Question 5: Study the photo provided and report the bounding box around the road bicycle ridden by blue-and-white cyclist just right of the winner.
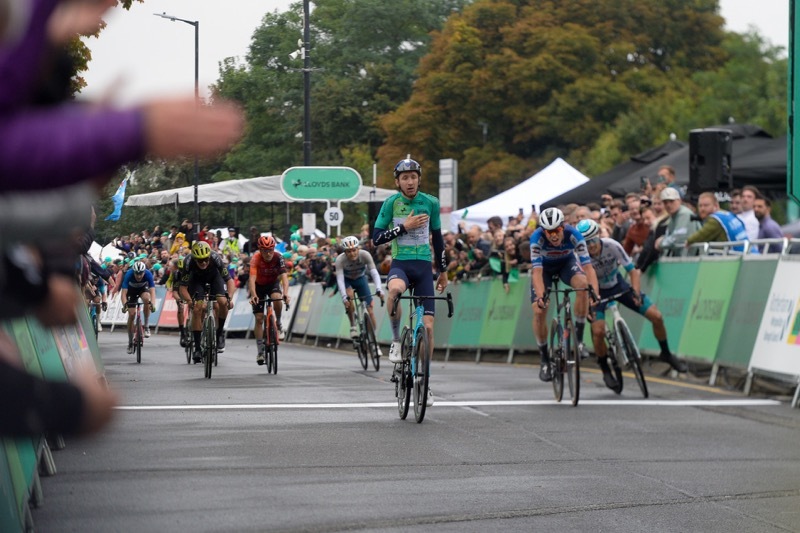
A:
[542,274,595,406]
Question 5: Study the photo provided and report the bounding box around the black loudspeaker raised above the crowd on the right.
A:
[689,129,733,193]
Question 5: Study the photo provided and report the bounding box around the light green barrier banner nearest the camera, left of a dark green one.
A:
[678,257,741,363]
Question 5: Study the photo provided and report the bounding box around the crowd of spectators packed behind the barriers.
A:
[103,166,783,294]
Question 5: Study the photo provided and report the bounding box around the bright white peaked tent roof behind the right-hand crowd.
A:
[450,157,589,231]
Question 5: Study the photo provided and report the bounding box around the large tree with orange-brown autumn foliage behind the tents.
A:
[378,0,725,205]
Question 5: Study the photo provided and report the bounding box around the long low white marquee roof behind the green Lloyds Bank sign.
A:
[125,176,395,207]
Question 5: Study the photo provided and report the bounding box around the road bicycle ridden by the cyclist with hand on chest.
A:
[391,286,453,424]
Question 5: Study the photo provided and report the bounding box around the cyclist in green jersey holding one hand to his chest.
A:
[372,157,447,405]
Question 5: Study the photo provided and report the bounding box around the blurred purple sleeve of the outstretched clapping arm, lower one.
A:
[0,105,144,192]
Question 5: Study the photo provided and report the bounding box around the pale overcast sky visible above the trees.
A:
[78,0,790,103]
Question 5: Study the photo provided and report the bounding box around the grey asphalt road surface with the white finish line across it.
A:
[33,332,800,533]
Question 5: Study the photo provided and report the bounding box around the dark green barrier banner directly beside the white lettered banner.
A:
[714,256,778,368]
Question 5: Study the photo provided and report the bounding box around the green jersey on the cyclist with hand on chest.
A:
[375,192,442,261]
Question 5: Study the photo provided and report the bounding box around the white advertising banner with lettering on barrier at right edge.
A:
[749,256,800,377]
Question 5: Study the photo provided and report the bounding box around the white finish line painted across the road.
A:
[116,399,781,411]
